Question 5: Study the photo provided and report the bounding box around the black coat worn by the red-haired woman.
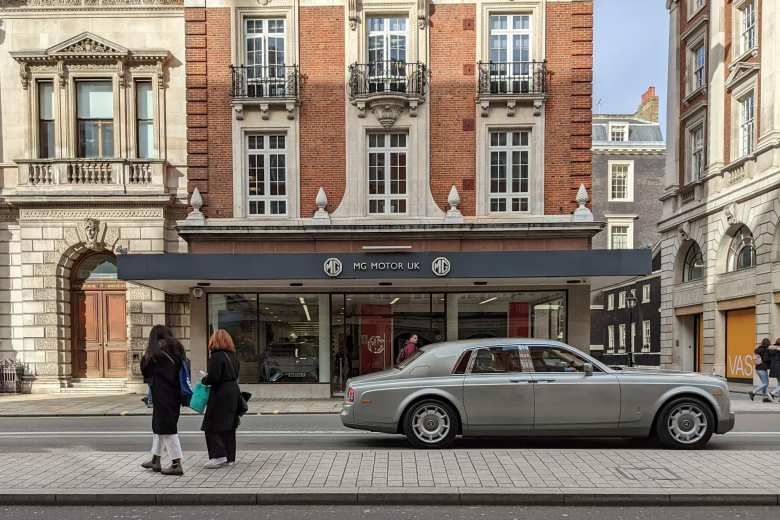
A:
[201,350,241,432]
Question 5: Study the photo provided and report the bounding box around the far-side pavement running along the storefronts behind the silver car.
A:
[0,392,780,417]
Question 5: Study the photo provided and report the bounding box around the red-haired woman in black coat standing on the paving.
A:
[201,329,242,469]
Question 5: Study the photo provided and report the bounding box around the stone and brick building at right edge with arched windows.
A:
[659,0,780,380]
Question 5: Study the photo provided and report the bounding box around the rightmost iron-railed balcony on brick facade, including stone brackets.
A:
[477,61,547,117]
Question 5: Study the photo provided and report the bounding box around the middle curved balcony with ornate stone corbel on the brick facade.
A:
[348,61,428,128]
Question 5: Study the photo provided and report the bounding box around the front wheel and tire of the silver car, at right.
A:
[655,397,715,450]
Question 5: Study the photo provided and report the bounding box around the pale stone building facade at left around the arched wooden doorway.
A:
[0,1,189,392]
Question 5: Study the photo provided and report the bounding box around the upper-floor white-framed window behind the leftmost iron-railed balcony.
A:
[244,18,286,97]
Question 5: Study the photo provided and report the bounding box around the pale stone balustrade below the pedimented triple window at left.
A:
[16,159,166,195]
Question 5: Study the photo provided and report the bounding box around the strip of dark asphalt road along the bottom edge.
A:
[0,506,778,520]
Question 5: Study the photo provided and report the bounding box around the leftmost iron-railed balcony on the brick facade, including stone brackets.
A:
[230,65,301,119]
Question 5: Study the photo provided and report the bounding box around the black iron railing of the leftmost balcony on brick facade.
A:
[230,65,300,98]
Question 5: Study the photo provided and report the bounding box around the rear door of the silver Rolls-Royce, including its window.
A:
[463,345,534,435]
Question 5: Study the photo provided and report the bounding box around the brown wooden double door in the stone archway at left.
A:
[71,286,127,378]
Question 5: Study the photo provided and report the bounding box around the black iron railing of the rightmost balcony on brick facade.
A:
[478,61,547,95]
